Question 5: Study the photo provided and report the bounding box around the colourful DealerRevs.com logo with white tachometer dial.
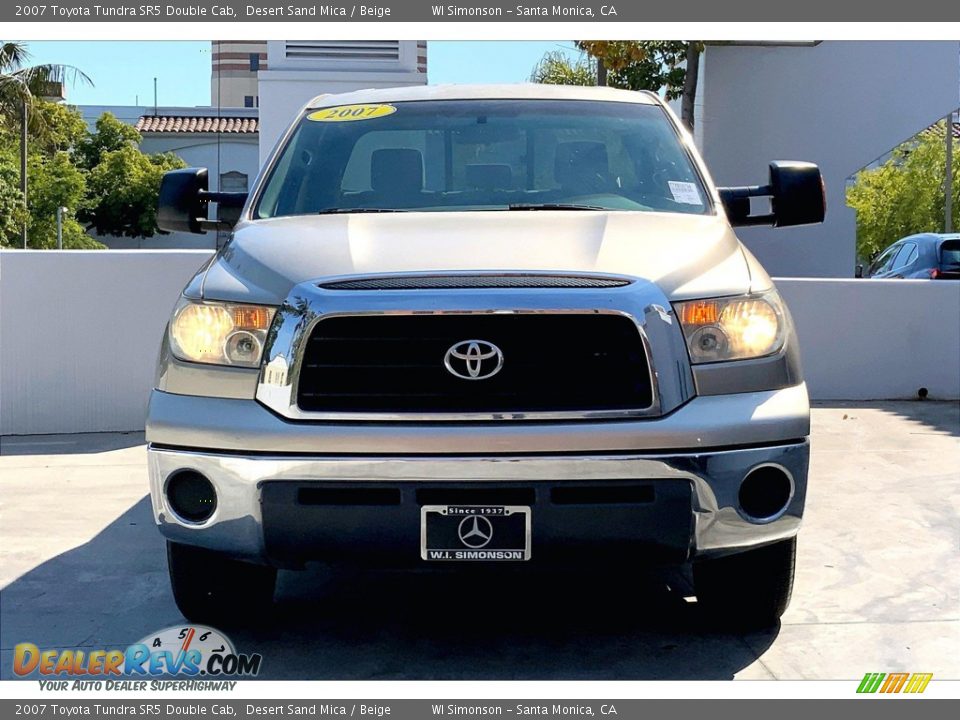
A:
[13,625,263,681]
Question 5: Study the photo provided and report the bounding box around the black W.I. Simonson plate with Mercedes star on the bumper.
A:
[420,505,530,562]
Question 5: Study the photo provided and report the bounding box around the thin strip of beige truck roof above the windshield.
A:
[307,83,660,108]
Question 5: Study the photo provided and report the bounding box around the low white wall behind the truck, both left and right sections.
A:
[0,250,960,434]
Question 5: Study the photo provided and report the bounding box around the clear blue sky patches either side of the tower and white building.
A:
[20,40,576,105]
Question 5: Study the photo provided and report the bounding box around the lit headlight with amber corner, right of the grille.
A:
[674,290,784,364]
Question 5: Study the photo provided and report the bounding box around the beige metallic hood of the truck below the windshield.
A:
[199,211,769,304]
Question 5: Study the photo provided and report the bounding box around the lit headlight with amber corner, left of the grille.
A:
[170,298,276,367]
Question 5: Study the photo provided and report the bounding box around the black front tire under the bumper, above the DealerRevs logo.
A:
[167,541,277,625]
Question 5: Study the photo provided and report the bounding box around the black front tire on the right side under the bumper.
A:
[693,537,797,629]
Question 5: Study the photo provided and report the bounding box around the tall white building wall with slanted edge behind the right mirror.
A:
[700,41,960,277]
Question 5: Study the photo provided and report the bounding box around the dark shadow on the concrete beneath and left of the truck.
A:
[0,497,779,680]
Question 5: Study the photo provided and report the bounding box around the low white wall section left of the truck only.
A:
[0,250,210,435]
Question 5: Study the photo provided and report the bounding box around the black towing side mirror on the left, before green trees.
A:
[157,168,247,233]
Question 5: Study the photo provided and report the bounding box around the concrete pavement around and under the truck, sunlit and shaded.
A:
[0,402,960,681]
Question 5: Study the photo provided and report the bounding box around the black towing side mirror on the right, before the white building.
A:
[719,160,827,227]
